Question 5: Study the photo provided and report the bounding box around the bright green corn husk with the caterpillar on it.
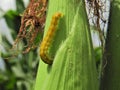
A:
[35,0,98,90]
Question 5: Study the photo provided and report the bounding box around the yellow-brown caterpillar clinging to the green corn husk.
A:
[40,12,63,65]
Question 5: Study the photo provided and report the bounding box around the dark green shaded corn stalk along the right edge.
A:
[101,0,120,90]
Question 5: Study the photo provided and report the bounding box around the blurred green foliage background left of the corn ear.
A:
[0,0,39,90]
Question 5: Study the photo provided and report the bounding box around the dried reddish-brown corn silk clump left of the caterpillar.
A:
[13,0,47,53]
